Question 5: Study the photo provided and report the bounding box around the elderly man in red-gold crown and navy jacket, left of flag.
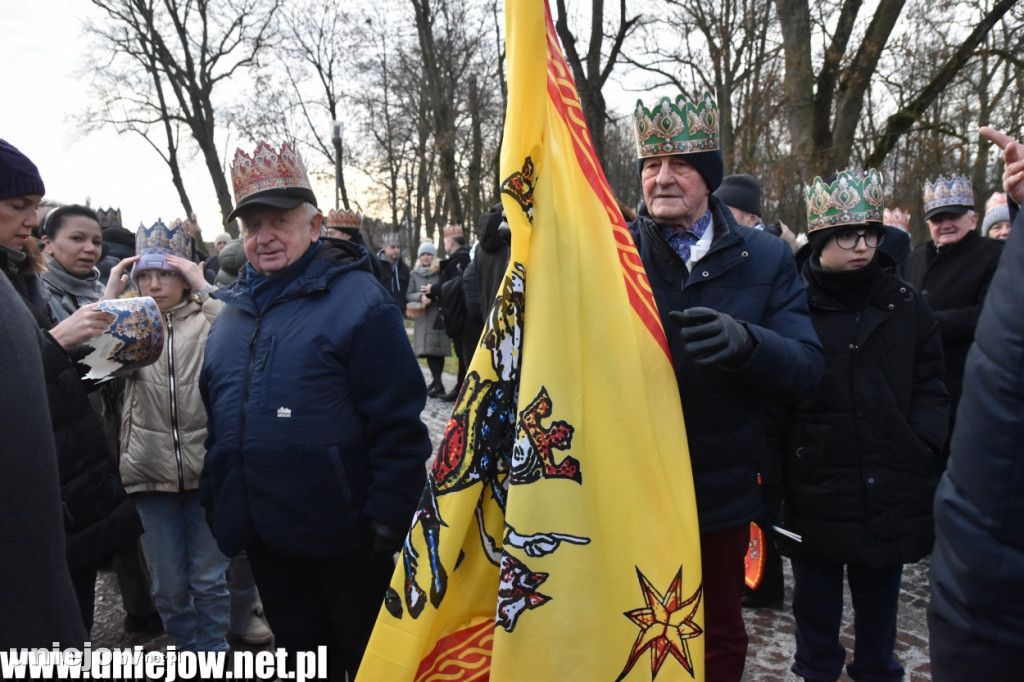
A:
[200,142,431,680]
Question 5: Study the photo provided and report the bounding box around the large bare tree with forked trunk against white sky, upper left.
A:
[85,0,281,231]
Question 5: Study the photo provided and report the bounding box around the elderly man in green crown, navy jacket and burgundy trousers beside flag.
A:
[631,93,824,682]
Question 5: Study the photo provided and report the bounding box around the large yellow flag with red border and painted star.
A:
[358,0,703,682]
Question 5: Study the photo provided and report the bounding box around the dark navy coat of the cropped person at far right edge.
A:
[928,205,1024,643]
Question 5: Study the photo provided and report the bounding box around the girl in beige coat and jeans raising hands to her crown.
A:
[108,223,230,651]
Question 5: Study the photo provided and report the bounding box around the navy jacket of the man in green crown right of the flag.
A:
[630,197,824,532]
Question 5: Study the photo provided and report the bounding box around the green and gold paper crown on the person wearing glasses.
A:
[807,168,885,232]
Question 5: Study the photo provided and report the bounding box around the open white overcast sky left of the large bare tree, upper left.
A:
[0,0,221,241]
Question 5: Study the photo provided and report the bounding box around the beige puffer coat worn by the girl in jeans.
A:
[121,293,224,493]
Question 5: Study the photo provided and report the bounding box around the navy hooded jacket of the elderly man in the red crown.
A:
[200,241,431,557]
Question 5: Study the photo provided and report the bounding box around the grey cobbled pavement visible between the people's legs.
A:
[92,370,932,682]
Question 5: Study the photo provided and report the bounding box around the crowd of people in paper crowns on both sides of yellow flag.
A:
[0,86,1024,682]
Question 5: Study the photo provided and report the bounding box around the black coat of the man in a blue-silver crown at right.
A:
[903,231,1002,411]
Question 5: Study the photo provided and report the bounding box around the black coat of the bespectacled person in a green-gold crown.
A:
[782,248,948,567]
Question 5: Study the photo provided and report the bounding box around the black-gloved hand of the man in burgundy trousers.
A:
[669,307,754,370]
